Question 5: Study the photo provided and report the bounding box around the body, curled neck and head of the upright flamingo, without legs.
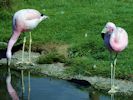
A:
[102,22,128,53]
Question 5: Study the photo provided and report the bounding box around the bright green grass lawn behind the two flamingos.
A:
[0,0,133,78]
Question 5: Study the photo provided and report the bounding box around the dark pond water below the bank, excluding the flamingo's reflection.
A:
[0,68,132,100]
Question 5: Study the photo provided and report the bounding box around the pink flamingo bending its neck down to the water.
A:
[6,9,48,65]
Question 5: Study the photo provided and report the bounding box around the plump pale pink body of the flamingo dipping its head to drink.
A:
[13,9,45,32]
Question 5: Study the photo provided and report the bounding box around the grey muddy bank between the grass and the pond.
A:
[0,51,133,95]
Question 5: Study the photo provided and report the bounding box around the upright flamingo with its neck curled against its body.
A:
[101,22,128,94]
